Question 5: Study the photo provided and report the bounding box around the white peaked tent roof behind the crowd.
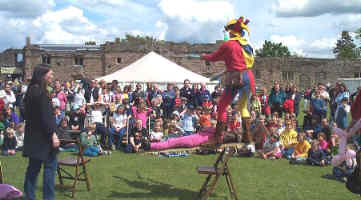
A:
[97,51,209,83]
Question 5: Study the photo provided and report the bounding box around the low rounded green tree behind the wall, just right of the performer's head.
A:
[256,40,291,57]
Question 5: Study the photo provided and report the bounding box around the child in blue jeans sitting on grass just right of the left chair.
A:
[80,123,109,157]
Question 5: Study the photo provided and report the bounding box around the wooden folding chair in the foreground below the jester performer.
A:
[197,148,238,200]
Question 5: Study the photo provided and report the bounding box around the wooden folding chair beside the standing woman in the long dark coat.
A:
[57,131,90,198]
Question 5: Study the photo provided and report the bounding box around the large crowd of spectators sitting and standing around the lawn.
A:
[0,79,361,180]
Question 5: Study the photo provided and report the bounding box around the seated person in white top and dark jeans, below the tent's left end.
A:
[108,105,130,150]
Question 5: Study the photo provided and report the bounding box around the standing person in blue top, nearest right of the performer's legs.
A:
[268,83,286,116]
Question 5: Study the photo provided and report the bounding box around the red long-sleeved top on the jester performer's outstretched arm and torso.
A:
[203,40,247,71]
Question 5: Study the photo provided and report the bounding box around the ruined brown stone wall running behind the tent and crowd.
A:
[0,40,361,88]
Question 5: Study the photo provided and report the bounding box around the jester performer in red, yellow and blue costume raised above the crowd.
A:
[202,17,256,144]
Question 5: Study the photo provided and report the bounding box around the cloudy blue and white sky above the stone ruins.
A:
[0,0,361,58]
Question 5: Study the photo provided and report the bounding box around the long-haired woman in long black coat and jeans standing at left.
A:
[23,65,60,200]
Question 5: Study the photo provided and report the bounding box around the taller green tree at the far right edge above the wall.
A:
[333,31,360,59]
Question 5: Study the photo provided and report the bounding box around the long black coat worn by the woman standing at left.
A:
[23,85,57,161]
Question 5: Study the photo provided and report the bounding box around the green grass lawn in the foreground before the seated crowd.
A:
[1,152,360,200]
